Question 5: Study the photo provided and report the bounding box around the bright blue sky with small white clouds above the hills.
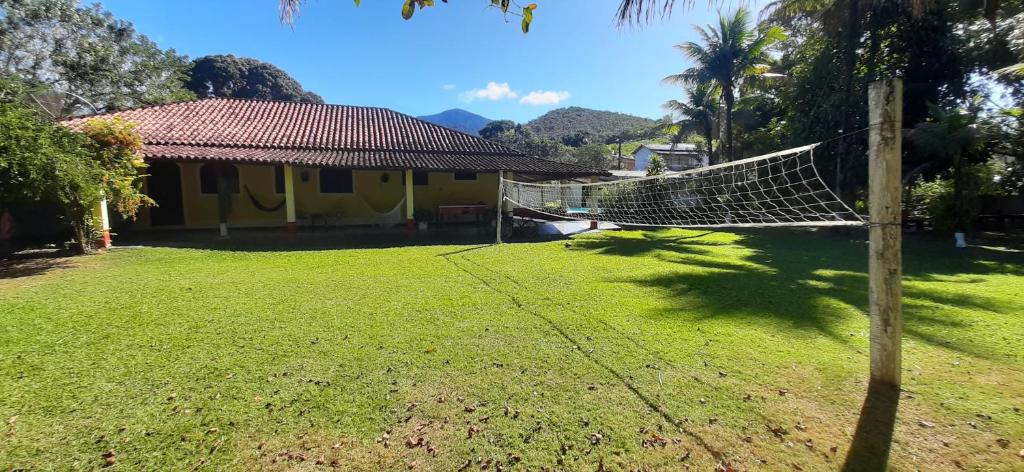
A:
[102,0,761,122]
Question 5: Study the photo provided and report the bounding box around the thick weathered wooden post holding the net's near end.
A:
[867,79,903,387]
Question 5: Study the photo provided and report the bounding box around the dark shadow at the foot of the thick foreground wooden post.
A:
[842,381,899,472]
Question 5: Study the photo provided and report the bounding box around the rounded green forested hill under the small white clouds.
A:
[526,106,657,141]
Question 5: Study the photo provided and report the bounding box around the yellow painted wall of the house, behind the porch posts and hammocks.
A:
[135,163,498,228]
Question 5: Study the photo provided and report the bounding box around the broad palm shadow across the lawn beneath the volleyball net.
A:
[572,229,1024,357]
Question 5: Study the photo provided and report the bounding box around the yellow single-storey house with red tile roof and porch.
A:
[63,98,604,237]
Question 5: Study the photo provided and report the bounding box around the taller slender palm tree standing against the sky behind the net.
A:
[665,8,785,161]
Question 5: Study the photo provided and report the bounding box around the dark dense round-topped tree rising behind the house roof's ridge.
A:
[185,54,324,103]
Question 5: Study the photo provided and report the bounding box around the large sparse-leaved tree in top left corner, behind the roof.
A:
[0,0,194,117]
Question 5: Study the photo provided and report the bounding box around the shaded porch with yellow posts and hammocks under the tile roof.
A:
[132,161,511,232]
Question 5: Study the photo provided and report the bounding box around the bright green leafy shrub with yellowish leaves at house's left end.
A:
[0,80,154,252]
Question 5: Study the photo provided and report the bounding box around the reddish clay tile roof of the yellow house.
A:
[63,98,604,176]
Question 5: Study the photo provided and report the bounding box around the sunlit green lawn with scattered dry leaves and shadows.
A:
[0,230,1024,470]
